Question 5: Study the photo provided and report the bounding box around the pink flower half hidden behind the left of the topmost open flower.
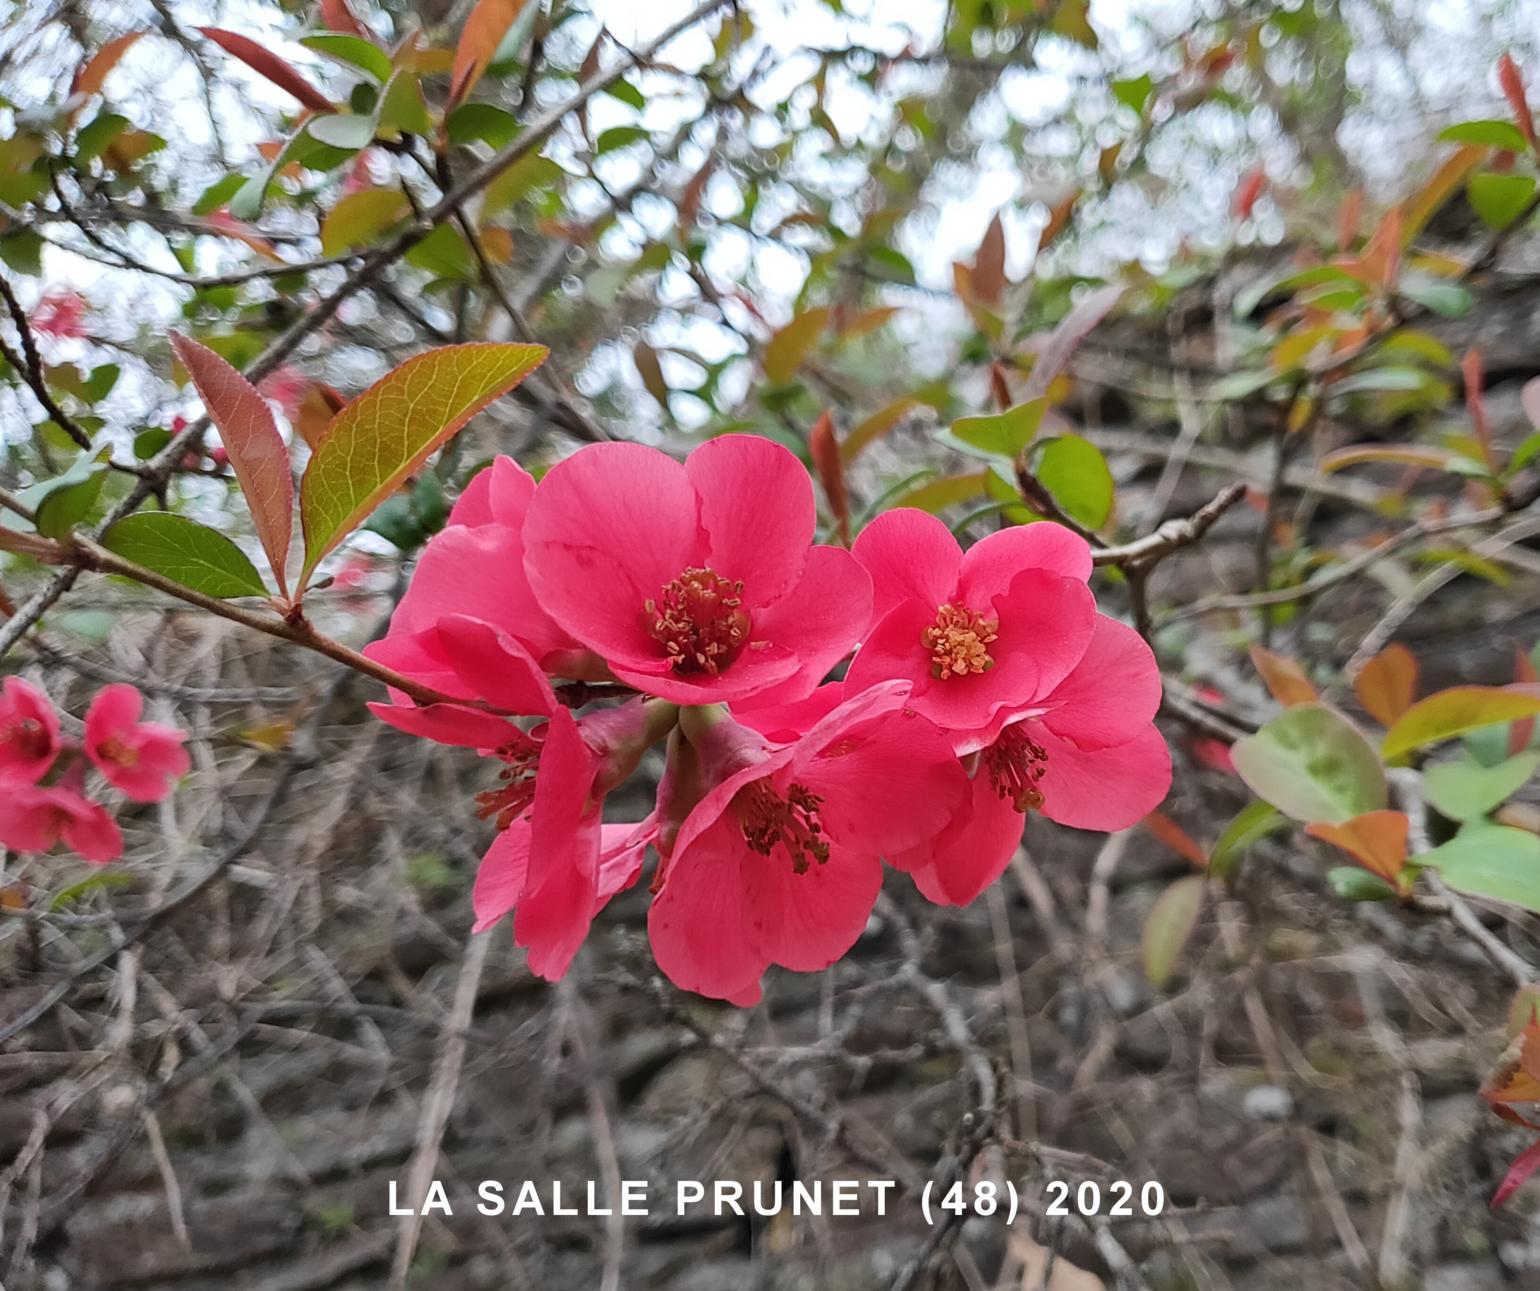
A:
[363,458,588,693]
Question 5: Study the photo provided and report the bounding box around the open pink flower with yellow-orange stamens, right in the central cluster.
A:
[845,507,1096,752]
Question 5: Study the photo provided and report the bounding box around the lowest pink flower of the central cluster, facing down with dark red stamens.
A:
[648,682,966,1004]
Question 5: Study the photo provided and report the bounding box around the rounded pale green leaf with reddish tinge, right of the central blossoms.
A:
[1230,704,1388,823]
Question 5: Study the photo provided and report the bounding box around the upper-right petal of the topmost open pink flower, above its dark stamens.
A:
[693,434,818,610]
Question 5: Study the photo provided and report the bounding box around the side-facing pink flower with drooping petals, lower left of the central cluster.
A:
[370,615,675,980]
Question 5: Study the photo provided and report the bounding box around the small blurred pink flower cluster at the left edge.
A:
[0,676,189,864]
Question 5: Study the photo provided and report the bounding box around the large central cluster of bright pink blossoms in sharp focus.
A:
[370,434,1170,1003]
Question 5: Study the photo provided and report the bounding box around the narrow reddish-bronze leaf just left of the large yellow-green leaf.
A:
[171,331,294,596]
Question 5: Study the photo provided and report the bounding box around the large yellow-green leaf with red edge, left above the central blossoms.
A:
[300,344,548,588]
